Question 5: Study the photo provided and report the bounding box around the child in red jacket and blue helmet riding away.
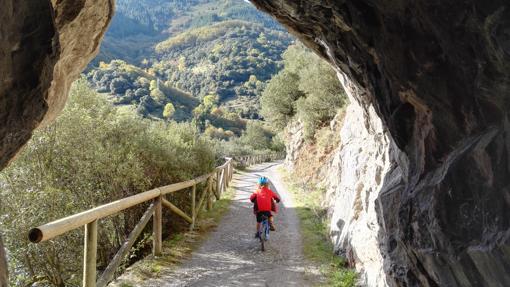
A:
[250,176,280,237]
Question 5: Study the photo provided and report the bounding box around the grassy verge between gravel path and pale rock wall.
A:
[279,168,357,287]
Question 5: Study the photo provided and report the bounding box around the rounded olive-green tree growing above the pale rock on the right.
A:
[261,44,346,138]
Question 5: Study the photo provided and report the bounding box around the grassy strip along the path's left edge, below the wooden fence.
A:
[108,188,235,287]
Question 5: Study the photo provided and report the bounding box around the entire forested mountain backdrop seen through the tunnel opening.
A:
[87,0,293,134]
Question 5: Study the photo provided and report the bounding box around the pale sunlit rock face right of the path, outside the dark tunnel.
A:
[286,77,390,286]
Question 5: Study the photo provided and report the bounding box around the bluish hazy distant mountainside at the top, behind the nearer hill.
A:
[93,0,284,66]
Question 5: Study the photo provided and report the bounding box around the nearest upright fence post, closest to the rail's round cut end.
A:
[83,219,97,287]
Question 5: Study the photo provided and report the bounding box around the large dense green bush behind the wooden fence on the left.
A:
[0,80,215,286]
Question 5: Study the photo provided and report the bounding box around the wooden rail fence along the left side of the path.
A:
[28,154,281,287]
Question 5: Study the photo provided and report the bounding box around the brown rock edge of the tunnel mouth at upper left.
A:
[0,0,113,286]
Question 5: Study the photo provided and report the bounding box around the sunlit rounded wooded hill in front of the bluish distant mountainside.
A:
[153,20,291,119]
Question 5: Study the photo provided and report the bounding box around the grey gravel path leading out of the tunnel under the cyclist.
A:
[144,162,319,286]
